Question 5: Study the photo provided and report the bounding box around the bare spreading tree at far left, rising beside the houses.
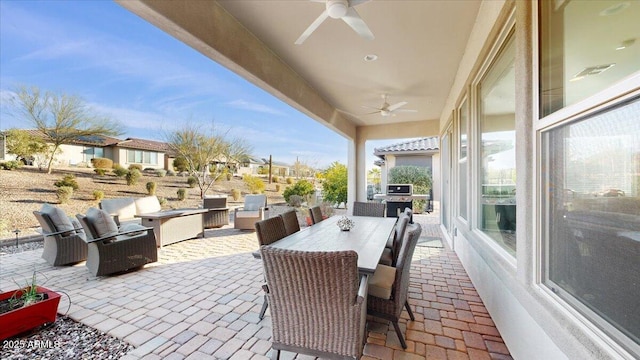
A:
[12,87,120,174]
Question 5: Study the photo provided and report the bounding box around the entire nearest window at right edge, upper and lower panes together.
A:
[537,0,640,356]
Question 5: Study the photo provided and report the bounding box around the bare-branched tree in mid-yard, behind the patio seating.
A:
[167,123,251,198]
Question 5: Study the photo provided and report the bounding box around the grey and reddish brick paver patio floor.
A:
[0,214,511,360]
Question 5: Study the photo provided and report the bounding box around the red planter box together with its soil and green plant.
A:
[0,272,60,340]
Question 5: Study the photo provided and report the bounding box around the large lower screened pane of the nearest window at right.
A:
[542,98,640,352]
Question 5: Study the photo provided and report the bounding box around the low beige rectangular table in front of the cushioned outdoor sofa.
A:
[136,209,209,247]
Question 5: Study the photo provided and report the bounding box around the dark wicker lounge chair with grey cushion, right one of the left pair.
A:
[76,208,158,276]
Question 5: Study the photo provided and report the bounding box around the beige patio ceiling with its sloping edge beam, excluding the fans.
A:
[119,0,481,138]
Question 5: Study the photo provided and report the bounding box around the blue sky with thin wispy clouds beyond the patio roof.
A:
[0,0,402,168]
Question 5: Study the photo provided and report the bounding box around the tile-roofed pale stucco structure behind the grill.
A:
[373,136,440,208]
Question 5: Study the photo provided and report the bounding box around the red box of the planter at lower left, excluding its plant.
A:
[0,286,60,340]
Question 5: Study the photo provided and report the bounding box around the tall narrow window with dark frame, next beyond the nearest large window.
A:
[478,34,516,256]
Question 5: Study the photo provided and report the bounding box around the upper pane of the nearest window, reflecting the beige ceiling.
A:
[539,0,640,117]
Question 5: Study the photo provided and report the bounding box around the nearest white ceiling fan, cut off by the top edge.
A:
[295,0,374,45]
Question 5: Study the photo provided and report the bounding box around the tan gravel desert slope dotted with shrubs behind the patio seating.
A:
[0,166,287,239]
